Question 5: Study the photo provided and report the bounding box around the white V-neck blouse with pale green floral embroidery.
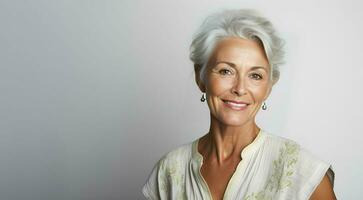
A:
[142,130,334,200]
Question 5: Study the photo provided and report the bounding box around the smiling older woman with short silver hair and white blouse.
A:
[143,10,335,200]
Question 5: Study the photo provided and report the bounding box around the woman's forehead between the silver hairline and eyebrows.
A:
[211,38,268,68]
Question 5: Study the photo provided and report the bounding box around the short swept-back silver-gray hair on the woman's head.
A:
[190,9,284,83]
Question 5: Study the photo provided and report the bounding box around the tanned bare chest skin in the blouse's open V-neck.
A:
[201,158,241,200]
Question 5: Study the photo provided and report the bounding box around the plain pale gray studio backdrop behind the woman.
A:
[0,0,363,200]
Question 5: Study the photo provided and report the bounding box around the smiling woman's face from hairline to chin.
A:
[199,38,272,126]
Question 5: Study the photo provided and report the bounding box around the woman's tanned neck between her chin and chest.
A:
[201,117,260,164]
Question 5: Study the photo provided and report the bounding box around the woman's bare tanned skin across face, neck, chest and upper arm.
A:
[195,38,334,200]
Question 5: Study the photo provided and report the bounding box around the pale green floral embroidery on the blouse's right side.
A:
[244,141,299,200]
